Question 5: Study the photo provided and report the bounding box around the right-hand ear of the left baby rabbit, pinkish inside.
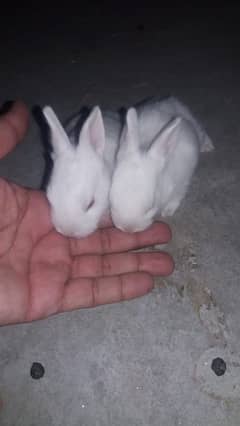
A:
[78,106,105,156]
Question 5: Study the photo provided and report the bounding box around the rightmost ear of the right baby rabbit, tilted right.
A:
[149,117,182,160]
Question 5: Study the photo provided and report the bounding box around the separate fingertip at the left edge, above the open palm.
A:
[0,101,29,158]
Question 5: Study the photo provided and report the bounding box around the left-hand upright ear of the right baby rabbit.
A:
[121,108,139,151]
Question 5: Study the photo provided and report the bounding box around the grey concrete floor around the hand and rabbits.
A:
[0,7,240,426]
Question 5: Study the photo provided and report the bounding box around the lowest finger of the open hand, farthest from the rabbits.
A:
[61,272,153,311]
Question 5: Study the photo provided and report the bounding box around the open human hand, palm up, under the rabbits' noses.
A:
[0,101,173,325]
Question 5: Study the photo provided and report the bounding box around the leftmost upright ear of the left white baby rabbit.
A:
[43,106,70,154]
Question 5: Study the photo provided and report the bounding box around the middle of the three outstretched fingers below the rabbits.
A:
[72,252,174,278]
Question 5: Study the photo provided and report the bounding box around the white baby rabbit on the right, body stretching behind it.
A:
[110,98,213,232]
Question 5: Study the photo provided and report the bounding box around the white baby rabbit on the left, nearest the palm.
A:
[43,106,121,237]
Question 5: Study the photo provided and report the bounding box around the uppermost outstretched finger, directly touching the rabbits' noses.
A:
[70,223,171,256]
